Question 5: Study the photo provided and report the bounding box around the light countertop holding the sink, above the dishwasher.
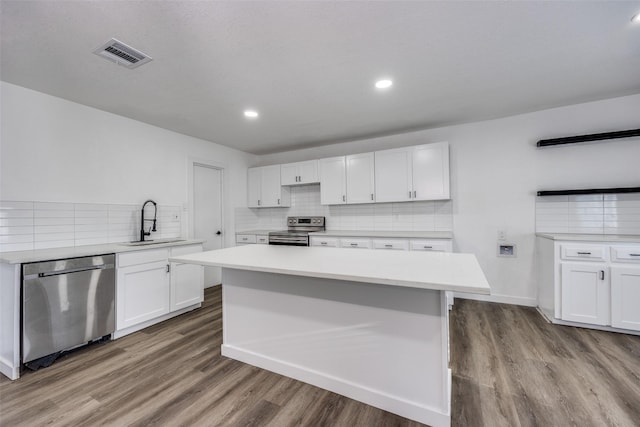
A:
[0,239,204,264]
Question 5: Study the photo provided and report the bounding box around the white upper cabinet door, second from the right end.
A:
[375,148,413,202]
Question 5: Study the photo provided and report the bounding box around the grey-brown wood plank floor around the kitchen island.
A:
[0,287,640,427]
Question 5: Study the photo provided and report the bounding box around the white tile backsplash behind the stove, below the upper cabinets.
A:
[235,184,453,231]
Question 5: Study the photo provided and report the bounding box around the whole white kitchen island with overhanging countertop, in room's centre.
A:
[170,245,490,426]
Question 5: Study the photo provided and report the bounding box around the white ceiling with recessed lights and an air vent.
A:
[0,0,640,154]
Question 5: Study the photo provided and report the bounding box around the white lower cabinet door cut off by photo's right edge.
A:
[611,267,640,331]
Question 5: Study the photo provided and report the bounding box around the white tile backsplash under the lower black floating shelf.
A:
[536,193,640,235]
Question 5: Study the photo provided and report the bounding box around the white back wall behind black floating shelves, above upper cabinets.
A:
[259,95,640,305]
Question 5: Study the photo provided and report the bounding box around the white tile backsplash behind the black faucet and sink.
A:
[0,200,182,252]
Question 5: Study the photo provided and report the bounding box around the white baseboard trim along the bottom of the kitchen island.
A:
[221,344,451,427]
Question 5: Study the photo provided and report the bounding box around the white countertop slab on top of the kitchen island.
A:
[169,245,490,294]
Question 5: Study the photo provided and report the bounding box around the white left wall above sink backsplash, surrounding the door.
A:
[0,82,257,246]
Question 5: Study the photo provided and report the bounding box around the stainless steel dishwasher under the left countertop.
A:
[22,254,115,369]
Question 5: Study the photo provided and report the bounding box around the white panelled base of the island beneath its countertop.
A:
[222,268,451,426]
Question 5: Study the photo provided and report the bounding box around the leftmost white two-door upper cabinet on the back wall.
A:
[247,165,291,208]
